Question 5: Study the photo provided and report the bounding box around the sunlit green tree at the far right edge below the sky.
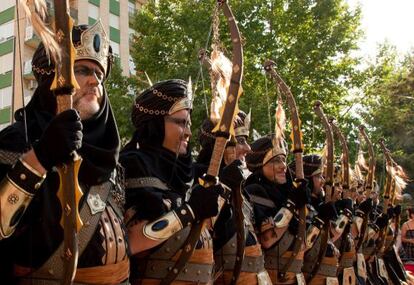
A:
[360,44,414,191]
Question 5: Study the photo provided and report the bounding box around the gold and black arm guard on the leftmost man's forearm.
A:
[0,159,46,240]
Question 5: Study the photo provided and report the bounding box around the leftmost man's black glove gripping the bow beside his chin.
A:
[33,109,83,170]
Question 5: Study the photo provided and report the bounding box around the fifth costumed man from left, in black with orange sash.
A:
[303,154,339,284]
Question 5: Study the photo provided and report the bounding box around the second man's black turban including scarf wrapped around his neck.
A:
[122,79,194,195]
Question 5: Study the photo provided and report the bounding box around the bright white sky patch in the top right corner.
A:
[347,0,414,57]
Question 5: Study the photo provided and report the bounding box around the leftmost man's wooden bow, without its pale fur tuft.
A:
[51,0,83,284]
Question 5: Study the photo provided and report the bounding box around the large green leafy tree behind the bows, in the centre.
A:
[132,0,363,152]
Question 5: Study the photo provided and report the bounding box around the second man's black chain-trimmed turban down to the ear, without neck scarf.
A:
[131,79,192,147]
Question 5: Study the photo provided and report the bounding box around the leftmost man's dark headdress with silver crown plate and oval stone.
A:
[32,21,113,85]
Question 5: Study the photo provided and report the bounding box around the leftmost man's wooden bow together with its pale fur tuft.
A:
[21,0,83,285]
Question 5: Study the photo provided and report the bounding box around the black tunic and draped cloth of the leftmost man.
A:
[0,81,119,282]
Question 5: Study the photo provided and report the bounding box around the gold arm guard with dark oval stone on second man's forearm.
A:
[143,204,194,241]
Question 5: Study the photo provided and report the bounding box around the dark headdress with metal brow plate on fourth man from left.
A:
[246,135,286,172]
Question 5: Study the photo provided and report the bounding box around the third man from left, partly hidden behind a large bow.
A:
[196,111,271,284]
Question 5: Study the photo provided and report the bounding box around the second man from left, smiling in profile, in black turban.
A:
[120,79,223,284]
